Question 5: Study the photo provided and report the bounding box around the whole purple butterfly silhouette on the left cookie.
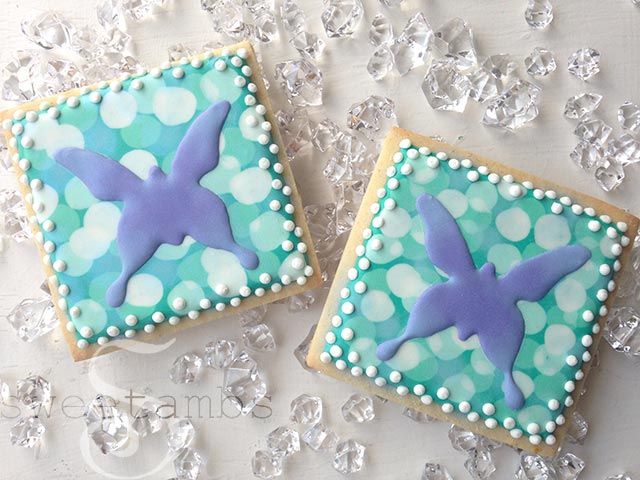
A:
[54,101,258,307]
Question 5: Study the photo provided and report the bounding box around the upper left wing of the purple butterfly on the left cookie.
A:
[53,147,143,201]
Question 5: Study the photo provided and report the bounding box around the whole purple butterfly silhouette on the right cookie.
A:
[376,194,591,409]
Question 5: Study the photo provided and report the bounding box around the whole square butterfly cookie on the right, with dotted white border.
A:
[307,129,638,455]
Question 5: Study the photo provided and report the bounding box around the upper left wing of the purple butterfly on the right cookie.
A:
[416,193,475,275]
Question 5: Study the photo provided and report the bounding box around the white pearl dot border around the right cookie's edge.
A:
[320,139,630,445]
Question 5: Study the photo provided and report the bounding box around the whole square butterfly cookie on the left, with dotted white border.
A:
[1,43,320,360]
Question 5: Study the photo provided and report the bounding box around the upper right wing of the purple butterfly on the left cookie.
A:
[170,101,231,182]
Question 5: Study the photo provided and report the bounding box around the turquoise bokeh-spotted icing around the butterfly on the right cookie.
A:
[324,143,622,441]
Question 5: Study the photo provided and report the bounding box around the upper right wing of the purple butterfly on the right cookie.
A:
[499,245,591,302]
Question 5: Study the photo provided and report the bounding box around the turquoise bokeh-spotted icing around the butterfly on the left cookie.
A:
[8,55,309,343]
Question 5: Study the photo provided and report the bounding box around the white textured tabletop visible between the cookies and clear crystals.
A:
[0,0,640,480]
